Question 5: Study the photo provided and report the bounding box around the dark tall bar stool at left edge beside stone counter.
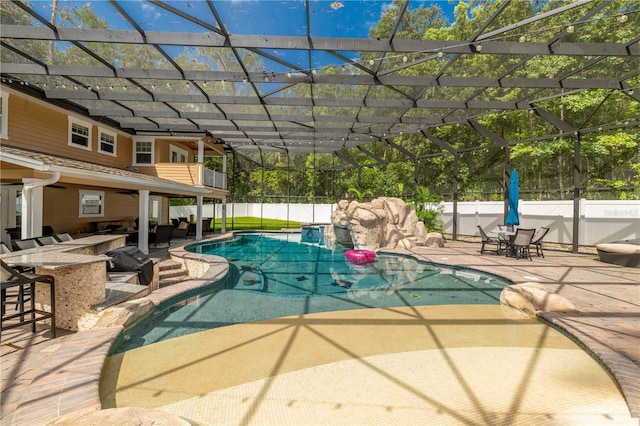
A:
[0,259,56,337]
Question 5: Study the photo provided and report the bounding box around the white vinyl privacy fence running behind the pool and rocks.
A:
[170,199,640,246]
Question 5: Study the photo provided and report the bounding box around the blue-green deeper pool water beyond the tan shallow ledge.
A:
[110,233,510,352]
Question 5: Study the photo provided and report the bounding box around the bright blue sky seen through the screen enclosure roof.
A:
[34,0,454,72]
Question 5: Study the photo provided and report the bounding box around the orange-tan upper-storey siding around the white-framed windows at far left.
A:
[6,95,131,168]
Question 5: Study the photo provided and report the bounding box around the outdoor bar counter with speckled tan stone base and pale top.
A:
[1,235,126,331]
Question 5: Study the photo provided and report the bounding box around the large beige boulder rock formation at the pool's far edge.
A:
[324,197,442,250]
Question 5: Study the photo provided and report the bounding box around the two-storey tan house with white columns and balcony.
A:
[0,84,228,252]
